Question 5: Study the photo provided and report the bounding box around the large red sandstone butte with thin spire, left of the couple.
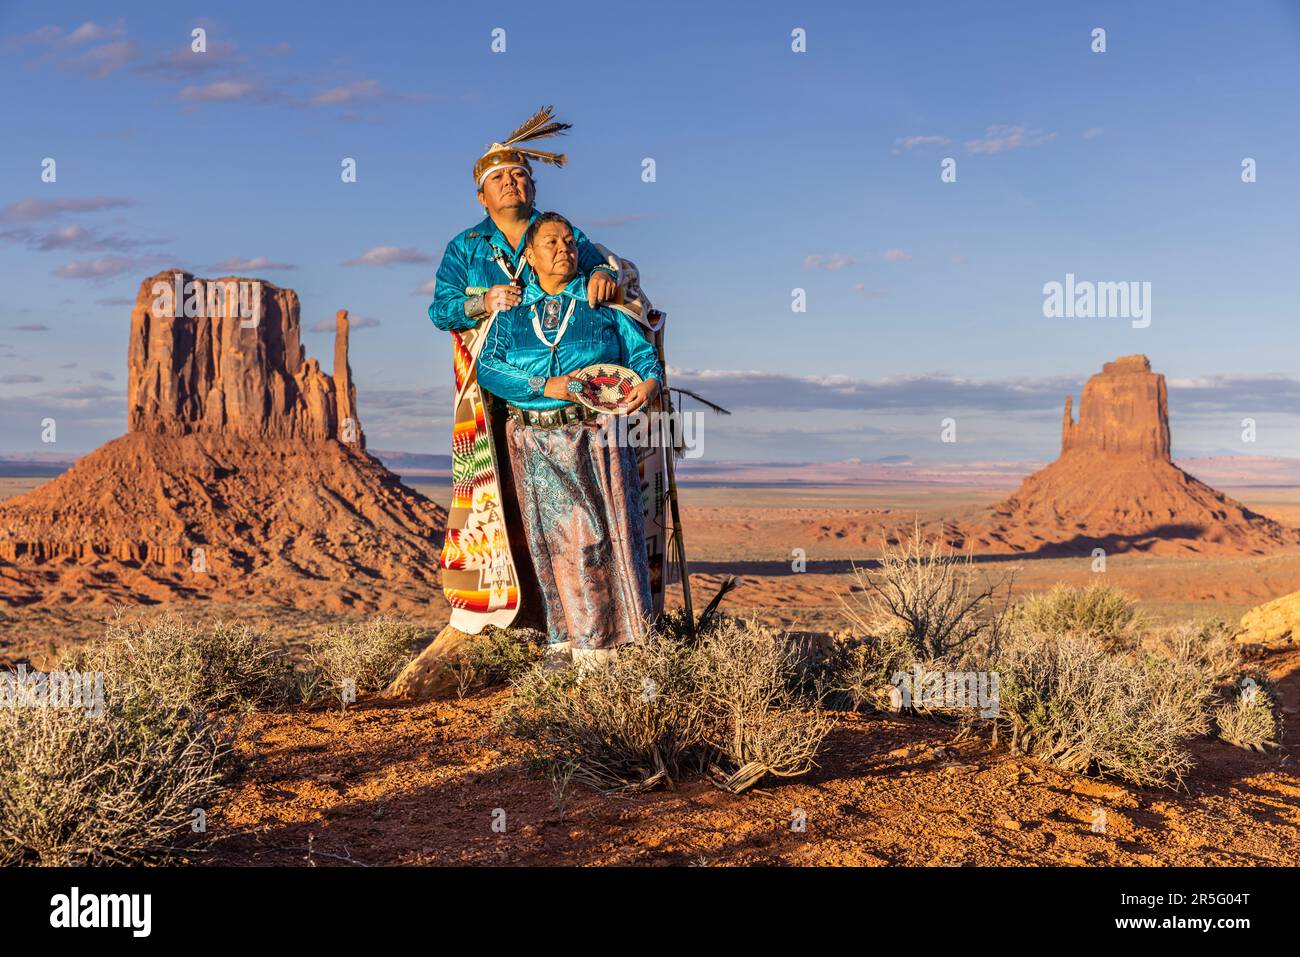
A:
[0,272,446,610]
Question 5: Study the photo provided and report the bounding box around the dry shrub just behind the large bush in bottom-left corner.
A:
[72,612,295,711]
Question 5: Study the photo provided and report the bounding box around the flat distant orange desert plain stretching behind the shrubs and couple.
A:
[0,477,1300,664]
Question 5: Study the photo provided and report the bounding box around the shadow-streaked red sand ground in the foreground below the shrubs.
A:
[199,646,1300,866]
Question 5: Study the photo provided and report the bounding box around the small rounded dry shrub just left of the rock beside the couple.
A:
[307,615,428,696]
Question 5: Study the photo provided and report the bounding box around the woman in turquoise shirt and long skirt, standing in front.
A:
[478,213,663,668]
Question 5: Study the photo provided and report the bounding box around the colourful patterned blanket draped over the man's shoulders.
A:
[442,246,671,635]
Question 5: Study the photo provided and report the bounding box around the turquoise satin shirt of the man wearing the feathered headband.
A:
[429,209,615,333]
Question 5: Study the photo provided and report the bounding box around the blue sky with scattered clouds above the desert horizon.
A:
[0,0,1300,460]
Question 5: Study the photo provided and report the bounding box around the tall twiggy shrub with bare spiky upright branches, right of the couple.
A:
[845,528,1011,659]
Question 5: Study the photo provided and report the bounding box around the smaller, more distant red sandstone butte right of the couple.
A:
[970,355,1300,555]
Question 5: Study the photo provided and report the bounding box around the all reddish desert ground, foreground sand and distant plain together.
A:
[0,480,1300,866]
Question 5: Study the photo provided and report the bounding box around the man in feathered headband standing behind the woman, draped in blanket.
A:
[429,107,616,633]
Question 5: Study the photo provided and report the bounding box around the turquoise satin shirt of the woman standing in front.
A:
[477,276,663,410]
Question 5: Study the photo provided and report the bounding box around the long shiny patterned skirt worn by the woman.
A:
[506,416,653,650]
